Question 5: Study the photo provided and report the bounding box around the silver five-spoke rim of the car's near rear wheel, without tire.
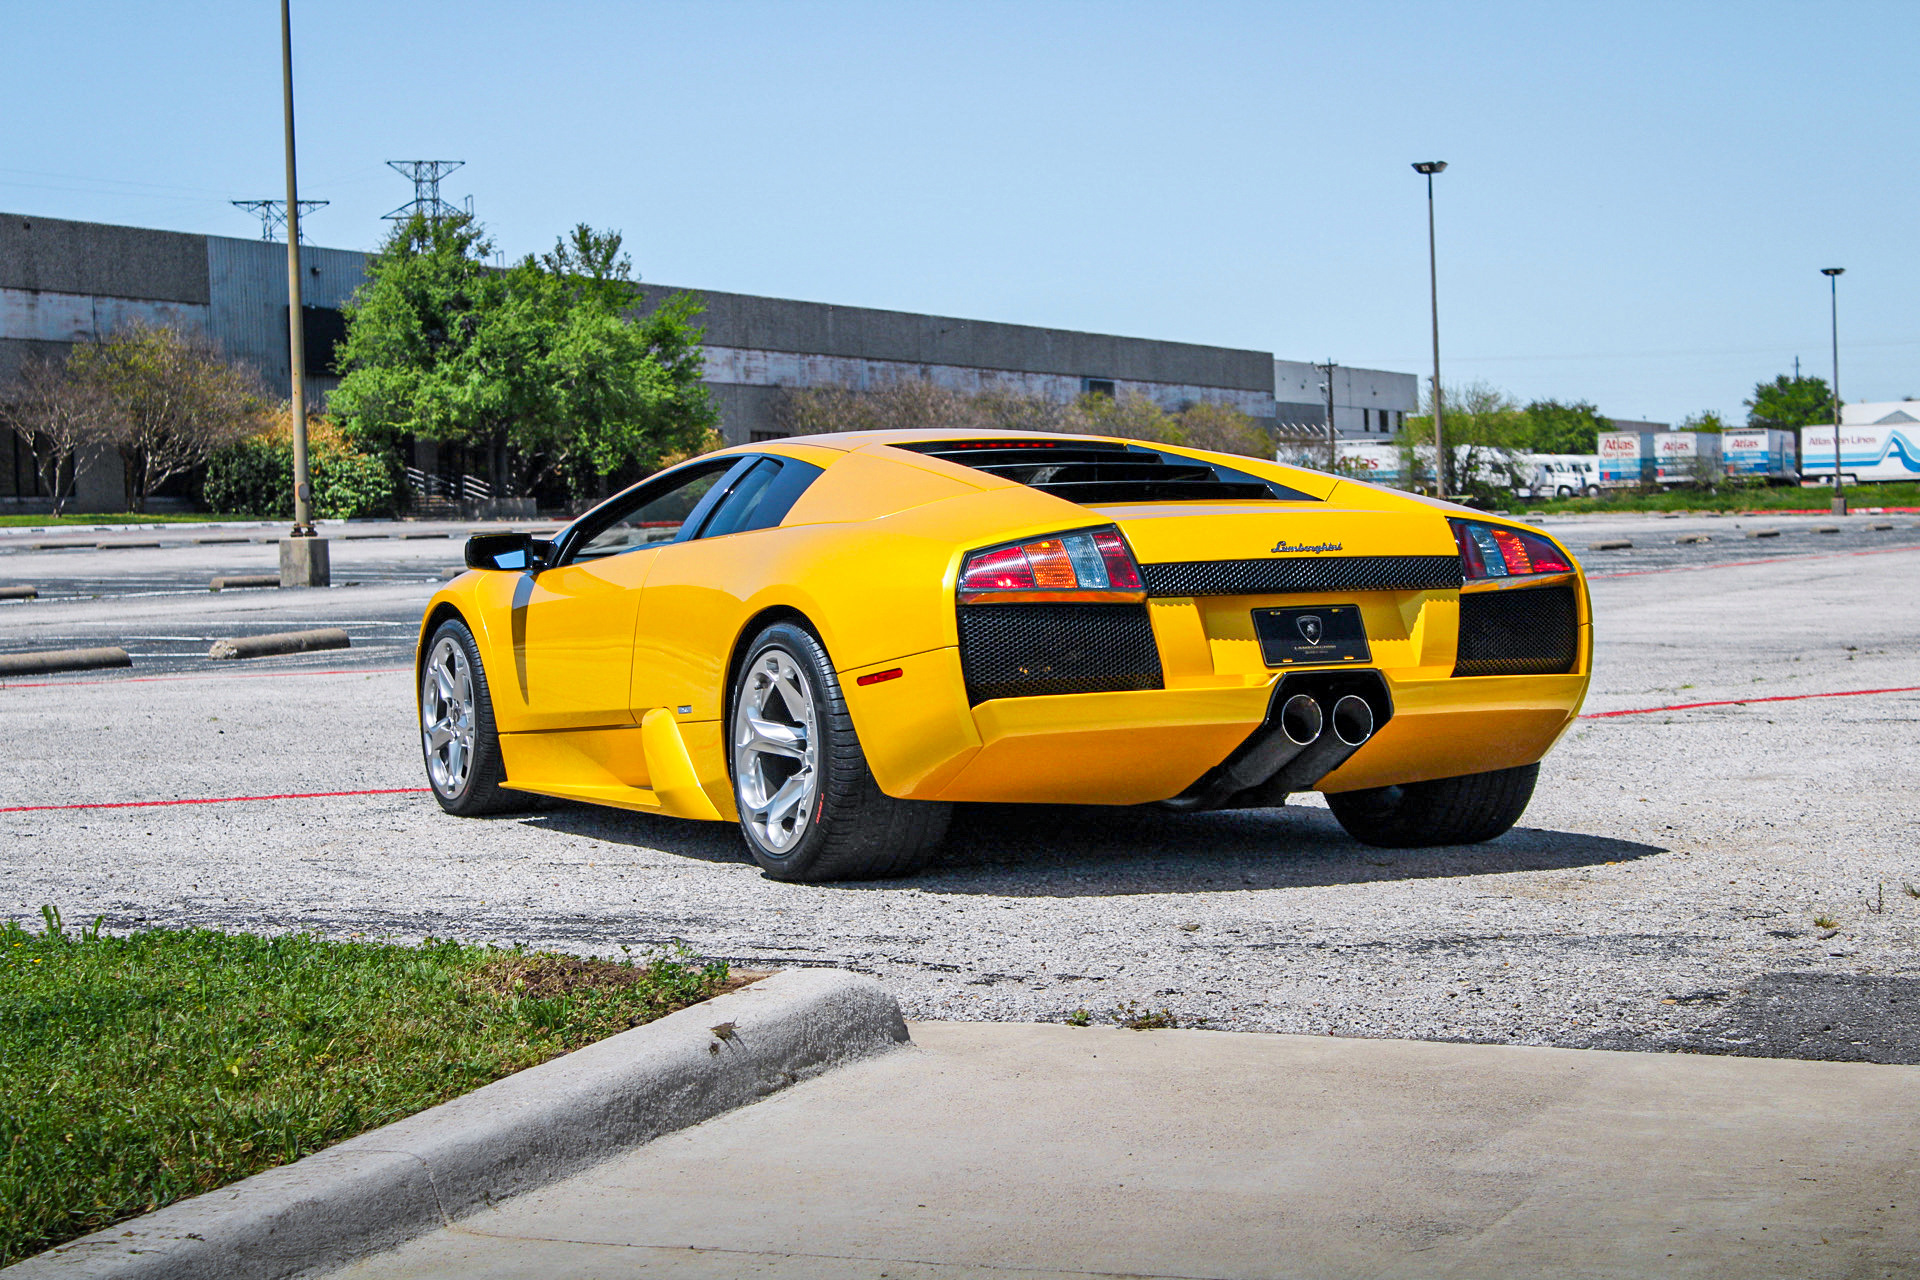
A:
[733,649,820,854]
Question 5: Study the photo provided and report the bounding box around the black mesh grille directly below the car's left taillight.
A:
[960,604,1164,702]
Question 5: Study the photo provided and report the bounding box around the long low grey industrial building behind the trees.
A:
[0,213,1417,510]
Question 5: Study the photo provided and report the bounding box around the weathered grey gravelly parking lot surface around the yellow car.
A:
[0,514,1920,1063]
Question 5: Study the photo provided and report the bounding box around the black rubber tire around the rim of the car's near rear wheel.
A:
[726,622,952,881]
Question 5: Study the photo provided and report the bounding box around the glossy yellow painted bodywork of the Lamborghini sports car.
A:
[422,422,1592,819]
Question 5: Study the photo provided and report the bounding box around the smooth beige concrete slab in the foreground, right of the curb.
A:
[340,1023,1920,1280]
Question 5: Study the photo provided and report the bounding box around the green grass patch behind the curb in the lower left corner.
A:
[0,912,728,1267]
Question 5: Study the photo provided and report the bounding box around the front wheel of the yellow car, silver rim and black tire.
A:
[420,618,526,818]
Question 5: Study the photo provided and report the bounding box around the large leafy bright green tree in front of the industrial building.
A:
[328,215,716,495]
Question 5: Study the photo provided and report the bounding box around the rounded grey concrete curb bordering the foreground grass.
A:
[0,969,906,1280]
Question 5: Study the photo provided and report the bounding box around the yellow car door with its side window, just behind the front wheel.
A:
[495,457,753,729]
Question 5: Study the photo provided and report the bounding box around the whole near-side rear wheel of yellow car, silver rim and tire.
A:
[728,622,952,881]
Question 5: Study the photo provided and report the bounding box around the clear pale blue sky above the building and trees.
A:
[0,0,1920,420]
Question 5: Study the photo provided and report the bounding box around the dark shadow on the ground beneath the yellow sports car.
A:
[516,802,1667,898]
